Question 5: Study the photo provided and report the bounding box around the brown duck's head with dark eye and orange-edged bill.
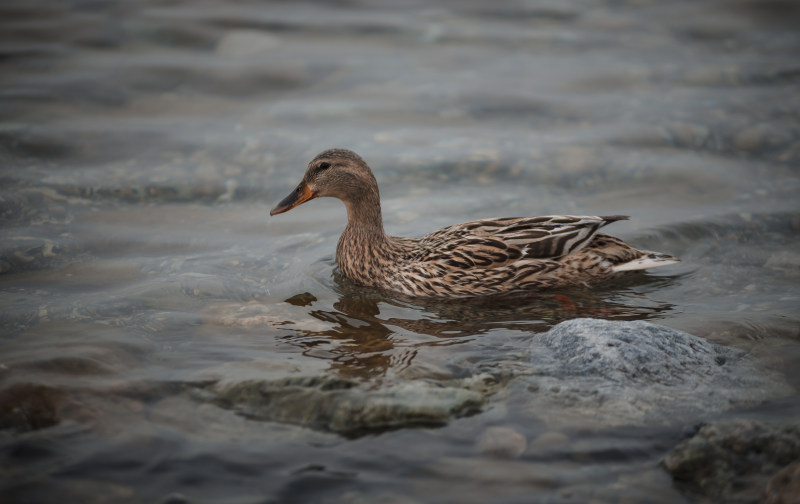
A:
[269,149,379,215]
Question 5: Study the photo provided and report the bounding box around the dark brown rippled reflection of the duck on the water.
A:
[284,270,672,378]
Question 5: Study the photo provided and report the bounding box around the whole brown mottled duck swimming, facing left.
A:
[270,149,679,298]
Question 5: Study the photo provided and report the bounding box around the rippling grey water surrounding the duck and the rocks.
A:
[0,0,800,503]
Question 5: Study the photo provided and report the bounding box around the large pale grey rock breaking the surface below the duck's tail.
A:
[525,319,789,428]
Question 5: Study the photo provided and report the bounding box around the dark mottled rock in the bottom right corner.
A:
[663,420,800,503]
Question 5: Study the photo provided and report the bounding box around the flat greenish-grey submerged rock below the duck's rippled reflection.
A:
[203,375,484,435]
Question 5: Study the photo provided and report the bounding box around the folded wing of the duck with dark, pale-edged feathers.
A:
[420,215,628,268]
